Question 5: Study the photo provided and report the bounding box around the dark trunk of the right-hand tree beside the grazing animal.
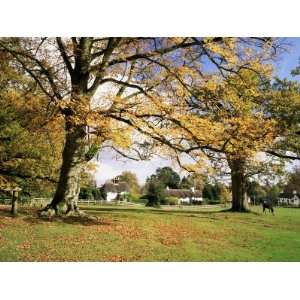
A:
[229,159,249,212]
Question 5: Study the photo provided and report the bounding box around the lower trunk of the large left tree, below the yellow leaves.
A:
[44,122,85,213]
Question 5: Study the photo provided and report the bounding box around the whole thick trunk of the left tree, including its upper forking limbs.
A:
[44,37,93,214]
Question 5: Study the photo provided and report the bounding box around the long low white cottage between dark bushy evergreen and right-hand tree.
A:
[165,186,203,204]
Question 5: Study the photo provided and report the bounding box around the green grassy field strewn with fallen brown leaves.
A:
[0,205,300,261]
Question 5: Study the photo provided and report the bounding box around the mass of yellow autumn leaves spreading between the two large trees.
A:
[53,38,277,171]
